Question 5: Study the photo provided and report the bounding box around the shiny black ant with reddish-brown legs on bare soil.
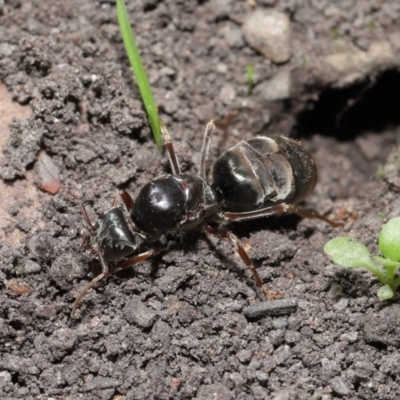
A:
[70,121,341,316]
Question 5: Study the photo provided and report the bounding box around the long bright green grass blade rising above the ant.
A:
[117,0,162,149]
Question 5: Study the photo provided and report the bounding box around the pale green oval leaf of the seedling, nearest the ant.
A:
[324,236,375,268]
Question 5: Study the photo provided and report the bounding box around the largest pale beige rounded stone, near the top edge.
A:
[242,10,290,63]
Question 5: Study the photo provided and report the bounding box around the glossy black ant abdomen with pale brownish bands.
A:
[212,136,317,211]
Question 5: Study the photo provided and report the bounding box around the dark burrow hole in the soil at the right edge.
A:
[294,70,400,140]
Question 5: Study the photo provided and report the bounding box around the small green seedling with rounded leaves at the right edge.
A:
[324,217,400,300]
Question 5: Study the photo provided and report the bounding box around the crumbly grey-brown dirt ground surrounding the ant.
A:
[0,0,400,400]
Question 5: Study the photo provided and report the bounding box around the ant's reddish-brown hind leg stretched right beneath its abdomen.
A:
[222,203,344,228]
